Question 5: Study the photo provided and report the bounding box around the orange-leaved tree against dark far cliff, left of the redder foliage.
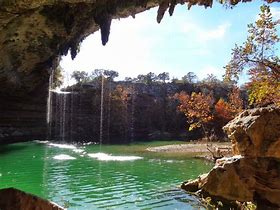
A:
[175,91,213,138]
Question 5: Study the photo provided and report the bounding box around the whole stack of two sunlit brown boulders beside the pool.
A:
[182,106,280,209]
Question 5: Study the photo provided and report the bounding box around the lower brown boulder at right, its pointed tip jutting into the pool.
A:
[181,156,280,209]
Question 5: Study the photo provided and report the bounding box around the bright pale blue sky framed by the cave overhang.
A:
[61,1,280,84]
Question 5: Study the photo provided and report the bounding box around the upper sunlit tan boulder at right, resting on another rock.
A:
[224,106,280,158]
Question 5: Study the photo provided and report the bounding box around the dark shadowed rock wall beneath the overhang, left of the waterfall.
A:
[0,95,47,144]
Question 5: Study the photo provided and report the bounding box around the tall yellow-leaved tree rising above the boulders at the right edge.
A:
[224,5,280,105]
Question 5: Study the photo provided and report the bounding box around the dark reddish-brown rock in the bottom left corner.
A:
[0,188,64,210]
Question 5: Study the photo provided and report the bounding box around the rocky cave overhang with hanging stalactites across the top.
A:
[0,0,279,95]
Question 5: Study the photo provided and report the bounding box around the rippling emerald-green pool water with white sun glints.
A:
[0,142,212,209]
